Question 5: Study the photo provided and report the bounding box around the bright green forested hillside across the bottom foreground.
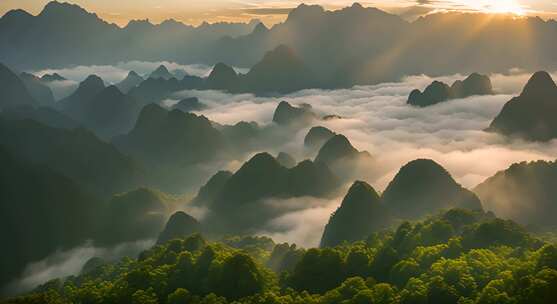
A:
[5,209,557,304]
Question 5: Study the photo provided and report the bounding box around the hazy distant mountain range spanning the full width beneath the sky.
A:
[0,2,557,92]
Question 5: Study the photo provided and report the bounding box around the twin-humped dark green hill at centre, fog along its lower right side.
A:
[202,153,339,233]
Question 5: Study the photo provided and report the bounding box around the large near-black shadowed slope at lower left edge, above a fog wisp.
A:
[0,147,100,286]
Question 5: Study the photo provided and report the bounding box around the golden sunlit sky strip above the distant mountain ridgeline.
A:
[0,0,557,26]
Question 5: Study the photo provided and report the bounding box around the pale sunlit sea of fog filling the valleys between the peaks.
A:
[18,63,557,294]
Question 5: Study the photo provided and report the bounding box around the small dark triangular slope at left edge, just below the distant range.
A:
[0,63,37,109]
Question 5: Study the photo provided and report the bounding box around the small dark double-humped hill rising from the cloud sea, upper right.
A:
[407,73,493,107]
